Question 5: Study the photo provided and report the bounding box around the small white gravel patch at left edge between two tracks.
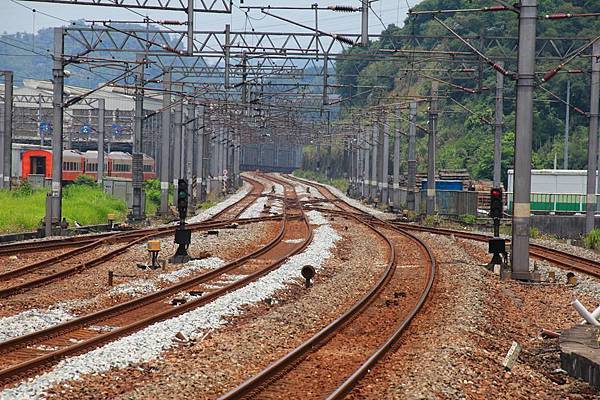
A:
[0,306,75,342]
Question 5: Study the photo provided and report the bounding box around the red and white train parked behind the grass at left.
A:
[21,149,156,182]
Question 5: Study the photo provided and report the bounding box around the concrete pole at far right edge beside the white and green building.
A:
[585,41,600,233]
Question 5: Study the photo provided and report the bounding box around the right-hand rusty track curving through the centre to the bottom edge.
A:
[221,178,435,399]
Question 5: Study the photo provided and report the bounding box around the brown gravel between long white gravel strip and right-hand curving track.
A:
[44,219,385,399]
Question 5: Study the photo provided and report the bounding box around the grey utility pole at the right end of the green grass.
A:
[131,53,145,220]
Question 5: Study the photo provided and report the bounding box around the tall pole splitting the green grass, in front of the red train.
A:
[45,28,65,236]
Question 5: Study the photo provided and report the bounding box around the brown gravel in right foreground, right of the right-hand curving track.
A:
[350,234,600,399]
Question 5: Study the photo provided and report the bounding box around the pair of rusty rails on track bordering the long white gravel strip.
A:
[0,173,313,384]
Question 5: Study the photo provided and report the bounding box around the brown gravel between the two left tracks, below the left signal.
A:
[0,222,279,316]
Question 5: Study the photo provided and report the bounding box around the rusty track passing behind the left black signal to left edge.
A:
[0,178,268,298]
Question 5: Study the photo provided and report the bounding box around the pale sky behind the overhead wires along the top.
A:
[0,0,419,34]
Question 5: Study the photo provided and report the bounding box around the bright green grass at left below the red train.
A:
[0,184,127,232]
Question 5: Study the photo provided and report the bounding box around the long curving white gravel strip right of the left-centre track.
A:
[0,211,340,400]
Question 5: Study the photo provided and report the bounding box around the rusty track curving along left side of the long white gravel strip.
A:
[0,173,313,387]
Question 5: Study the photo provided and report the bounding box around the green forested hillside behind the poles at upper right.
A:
[324,0,600,184]
